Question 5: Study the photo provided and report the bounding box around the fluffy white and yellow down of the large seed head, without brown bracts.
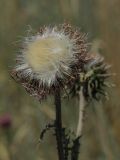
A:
[16,28,76,86]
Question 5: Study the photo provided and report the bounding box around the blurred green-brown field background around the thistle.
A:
[0,0,120,160]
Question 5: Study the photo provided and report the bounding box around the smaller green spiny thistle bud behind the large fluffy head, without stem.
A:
[69,54,113,100]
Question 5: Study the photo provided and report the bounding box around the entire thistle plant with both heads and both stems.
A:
[11,23,112,160]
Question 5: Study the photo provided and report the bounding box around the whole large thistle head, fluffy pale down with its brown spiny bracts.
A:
[12,24,91,100]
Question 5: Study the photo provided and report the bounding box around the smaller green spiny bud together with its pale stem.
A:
[68,55,113,136]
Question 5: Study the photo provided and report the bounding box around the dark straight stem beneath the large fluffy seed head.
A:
[55,88,64,160]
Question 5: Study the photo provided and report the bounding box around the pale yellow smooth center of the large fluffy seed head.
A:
[25,36,70,72]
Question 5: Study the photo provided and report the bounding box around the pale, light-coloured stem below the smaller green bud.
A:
[76,86,85,137]
